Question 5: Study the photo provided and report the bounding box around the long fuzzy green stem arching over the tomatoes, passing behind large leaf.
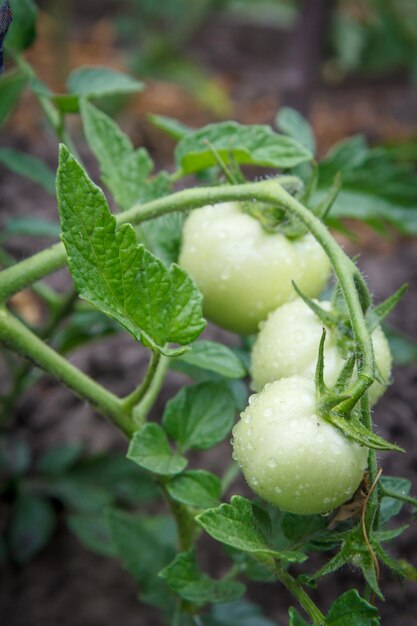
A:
[0,180,374,428]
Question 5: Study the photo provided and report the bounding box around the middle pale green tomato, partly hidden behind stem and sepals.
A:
[251,298,392,406]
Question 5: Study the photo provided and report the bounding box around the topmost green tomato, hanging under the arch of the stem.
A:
[179,202,330,334]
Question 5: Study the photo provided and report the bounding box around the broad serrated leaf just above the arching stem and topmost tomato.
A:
[175,122,312,174]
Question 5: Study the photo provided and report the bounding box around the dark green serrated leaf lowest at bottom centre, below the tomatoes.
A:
[159,551,245,605]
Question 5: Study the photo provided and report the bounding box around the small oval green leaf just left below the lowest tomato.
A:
[166,470,221,509]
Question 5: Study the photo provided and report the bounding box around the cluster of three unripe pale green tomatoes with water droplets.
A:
[180,202,391,515]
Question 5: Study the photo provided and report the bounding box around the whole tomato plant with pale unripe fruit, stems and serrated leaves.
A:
[0,7,417,626]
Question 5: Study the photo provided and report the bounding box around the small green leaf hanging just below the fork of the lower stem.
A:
[127,423,187,476]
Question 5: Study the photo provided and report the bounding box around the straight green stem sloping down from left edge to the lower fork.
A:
[0,309,132,435]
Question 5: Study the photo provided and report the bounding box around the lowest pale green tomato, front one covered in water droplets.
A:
[232,376,368,515]
